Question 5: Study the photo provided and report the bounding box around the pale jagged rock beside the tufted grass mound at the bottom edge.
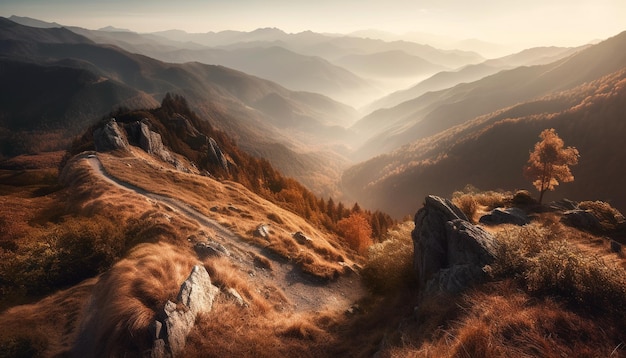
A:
[151,265,219,358]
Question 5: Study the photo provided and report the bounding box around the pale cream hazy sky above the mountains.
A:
[0,0,626,45]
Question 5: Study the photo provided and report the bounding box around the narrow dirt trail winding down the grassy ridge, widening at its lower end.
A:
[85,155,365,312]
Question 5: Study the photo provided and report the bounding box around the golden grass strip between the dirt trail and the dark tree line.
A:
[98,150,357,279]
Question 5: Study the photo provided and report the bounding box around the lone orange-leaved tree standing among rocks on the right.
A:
[524,128,579,204]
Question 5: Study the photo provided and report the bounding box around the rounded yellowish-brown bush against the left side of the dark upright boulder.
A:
[363,221,415,293]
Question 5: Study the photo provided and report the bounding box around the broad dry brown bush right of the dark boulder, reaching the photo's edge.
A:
[491,224,626,312]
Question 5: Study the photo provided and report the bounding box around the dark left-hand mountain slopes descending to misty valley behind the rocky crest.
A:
[0,19,356,193]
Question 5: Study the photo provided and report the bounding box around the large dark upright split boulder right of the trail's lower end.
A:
[411,196,496,294]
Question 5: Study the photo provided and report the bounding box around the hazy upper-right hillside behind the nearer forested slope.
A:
[353,33,626,160]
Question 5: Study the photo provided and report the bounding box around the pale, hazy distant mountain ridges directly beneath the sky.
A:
[11,17,483,106]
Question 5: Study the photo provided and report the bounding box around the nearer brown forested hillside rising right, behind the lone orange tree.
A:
[343,69,626,216]
